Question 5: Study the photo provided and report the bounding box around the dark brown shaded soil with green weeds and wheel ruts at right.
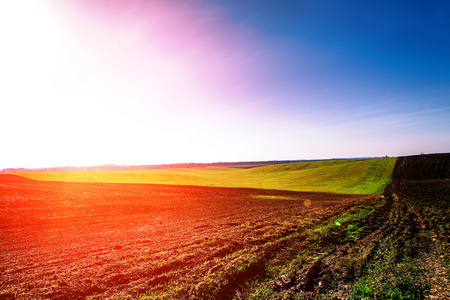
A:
[251,154,450,299]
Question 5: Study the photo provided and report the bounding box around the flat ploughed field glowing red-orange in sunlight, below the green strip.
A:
[0,175,371,299]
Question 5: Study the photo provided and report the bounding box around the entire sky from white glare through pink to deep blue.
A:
[0,0,450,169]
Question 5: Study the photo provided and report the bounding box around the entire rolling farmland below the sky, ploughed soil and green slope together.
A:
[0,154,450,299]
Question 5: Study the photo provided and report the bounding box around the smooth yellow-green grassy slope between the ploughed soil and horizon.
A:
[16,158,396,194]
